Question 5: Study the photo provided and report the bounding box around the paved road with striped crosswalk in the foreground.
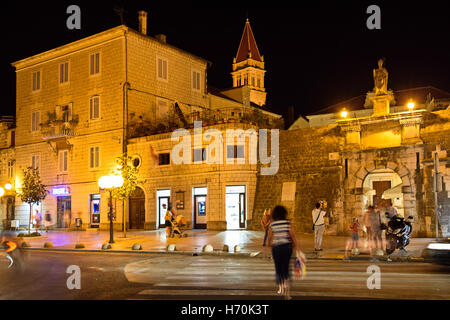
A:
[0,252,450,300]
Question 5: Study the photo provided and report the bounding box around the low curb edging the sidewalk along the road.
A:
[22,248,426,263]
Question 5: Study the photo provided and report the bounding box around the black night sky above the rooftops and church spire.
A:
[0,0,450,122]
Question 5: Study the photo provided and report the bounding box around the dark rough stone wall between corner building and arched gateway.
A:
[249,126,344,233]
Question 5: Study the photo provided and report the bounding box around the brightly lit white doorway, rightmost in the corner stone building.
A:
[225,186,247,230]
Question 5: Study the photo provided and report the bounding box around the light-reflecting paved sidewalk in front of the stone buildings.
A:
[4,230,433,261]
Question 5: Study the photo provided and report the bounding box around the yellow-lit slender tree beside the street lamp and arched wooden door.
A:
[112,153,140,237]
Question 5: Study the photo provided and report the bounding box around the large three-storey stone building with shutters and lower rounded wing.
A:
[9,11,282,229]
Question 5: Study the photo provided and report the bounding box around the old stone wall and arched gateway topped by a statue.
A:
[250,63,450,237]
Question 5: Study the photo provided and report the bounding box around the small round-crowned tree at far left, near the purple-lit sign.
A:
[19,167,48,234]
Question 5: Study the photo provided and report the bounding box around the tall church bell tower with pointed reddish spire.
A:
[231,19,267,107]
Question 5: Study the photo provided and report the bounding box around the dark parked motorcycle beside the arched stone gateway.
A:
[386,216,414,255]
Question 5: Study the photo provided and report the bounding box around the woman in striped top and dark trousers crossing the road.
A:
[269,206,299,300]
